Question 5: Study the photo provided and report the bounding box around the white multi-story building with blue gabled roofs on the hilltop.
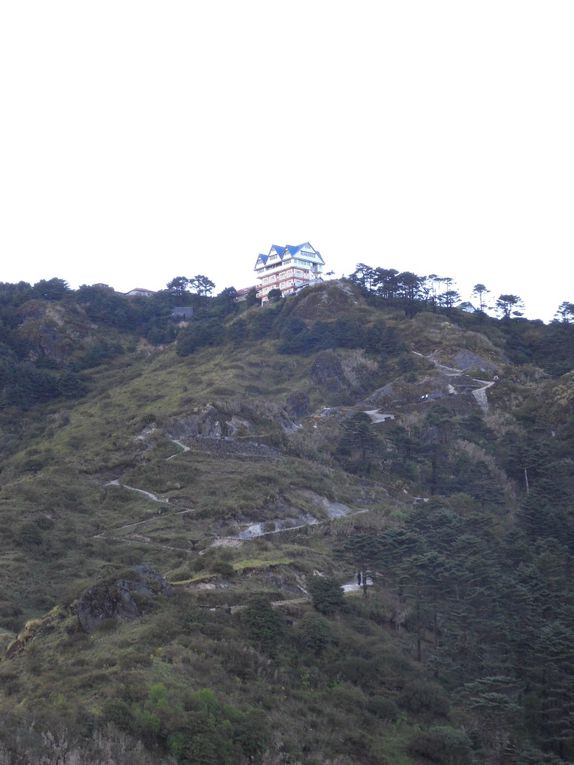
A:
[255,242,325,303]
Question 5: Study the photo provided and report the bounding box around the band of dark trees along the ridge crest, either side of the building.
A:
[0,264,574,409]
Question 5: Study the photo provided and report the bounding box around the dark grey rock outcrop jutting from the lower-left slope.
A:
[76,565,172,632]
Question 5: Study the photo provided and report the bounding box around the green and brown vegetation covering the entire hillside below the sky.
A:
[0,272,574,765]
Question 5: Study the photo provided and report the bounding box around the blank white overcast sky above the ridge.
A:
[0,0,574,320]
